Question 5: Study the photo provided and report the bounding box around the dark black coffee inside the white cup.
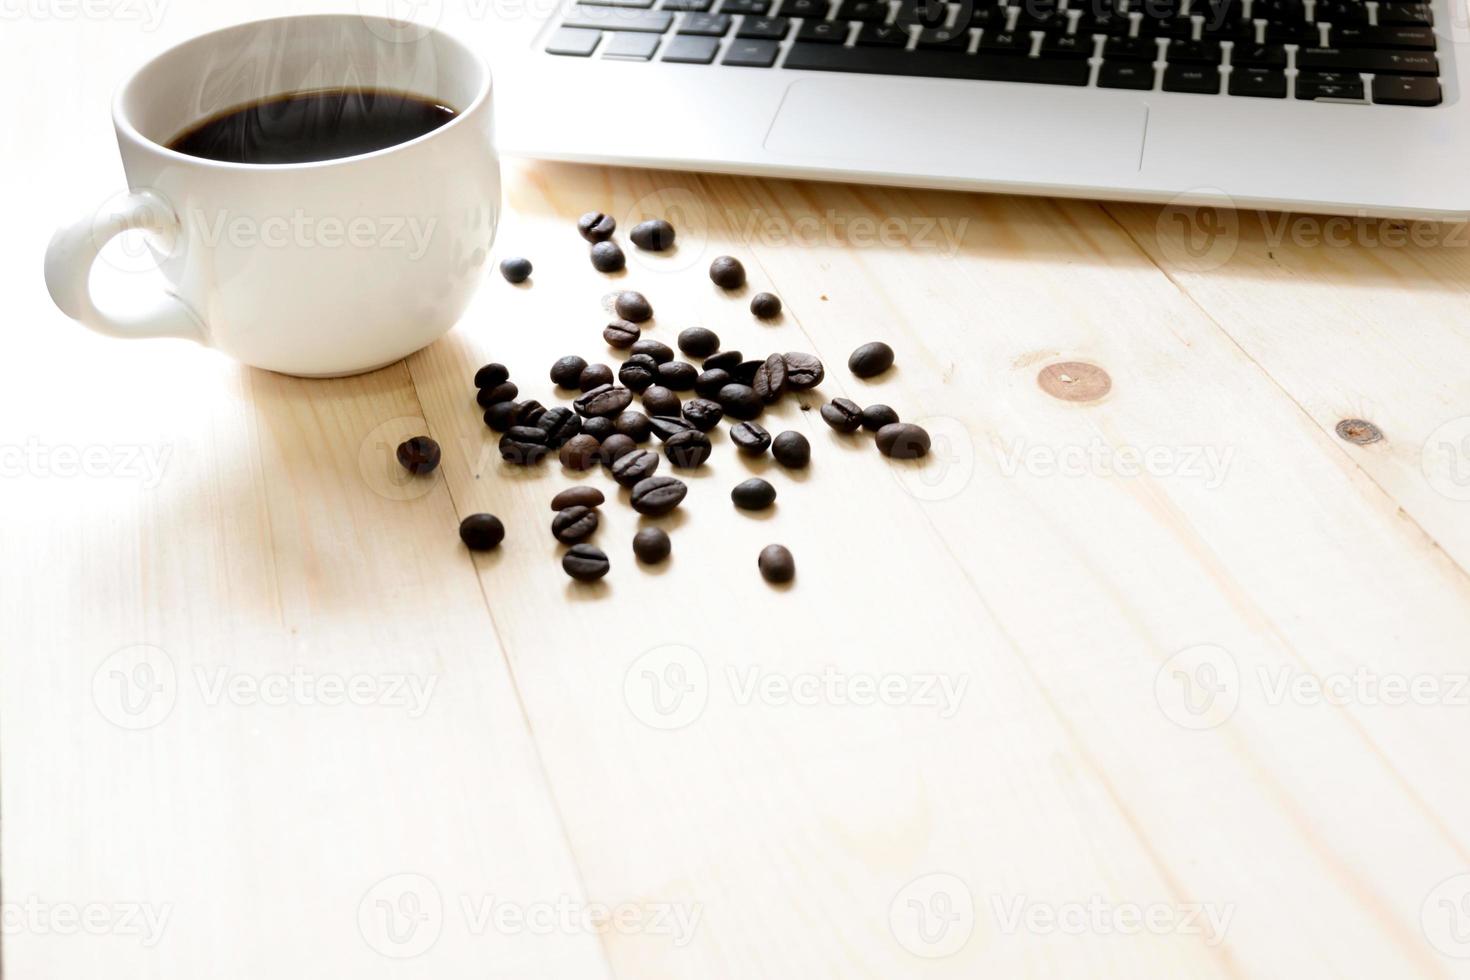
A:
[169,88,456,165]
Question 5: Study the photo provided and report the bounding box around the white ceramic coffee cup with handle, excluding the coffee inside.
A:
[46,15,500,378]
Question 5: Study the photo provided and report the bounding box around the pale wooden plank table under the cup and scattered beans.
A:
[0,4,1470,980]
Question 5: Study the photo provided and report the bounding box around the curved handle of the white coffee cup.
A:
[46,191,206,344]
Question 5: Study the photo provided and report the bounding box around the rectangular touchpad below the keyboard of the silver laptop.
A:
[766,75,1148,181]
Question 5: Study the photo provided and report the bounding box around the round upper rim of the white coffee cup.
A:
[112,13,494,173]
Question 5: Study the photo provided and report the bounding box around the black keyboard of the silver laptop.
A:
[545,0,1442,107]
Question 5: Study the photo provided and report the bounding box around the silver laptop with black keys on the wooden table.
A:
[497,0,1470,220]
